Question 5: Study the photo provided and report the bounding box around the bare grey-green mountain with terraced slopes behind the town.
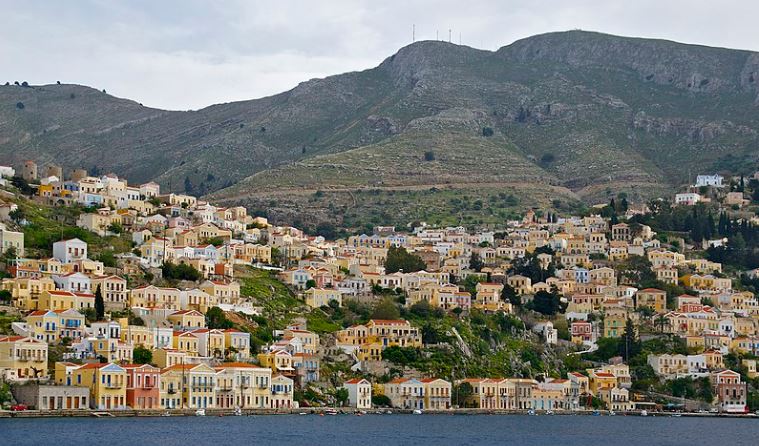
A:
[0,31,759,227]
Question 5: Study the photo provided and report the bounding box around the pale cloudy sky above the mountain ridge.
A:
[0,0,759,110]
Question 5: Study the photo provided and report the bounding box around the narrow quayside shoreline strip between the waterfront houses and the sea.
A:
[0,407,759,419]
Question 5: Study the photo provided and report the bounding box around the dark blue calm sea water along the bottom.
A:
[0,415,759,446]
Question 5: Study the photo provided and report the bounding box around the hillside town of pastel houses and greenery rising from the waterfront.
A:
[0,161,759,414]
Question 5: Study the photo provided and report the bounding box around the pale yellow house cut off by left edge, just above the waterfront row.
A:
[0,336,47,381]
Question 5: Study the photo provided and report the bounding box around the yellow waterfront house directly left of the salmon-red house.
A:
[71,363,127,410]
